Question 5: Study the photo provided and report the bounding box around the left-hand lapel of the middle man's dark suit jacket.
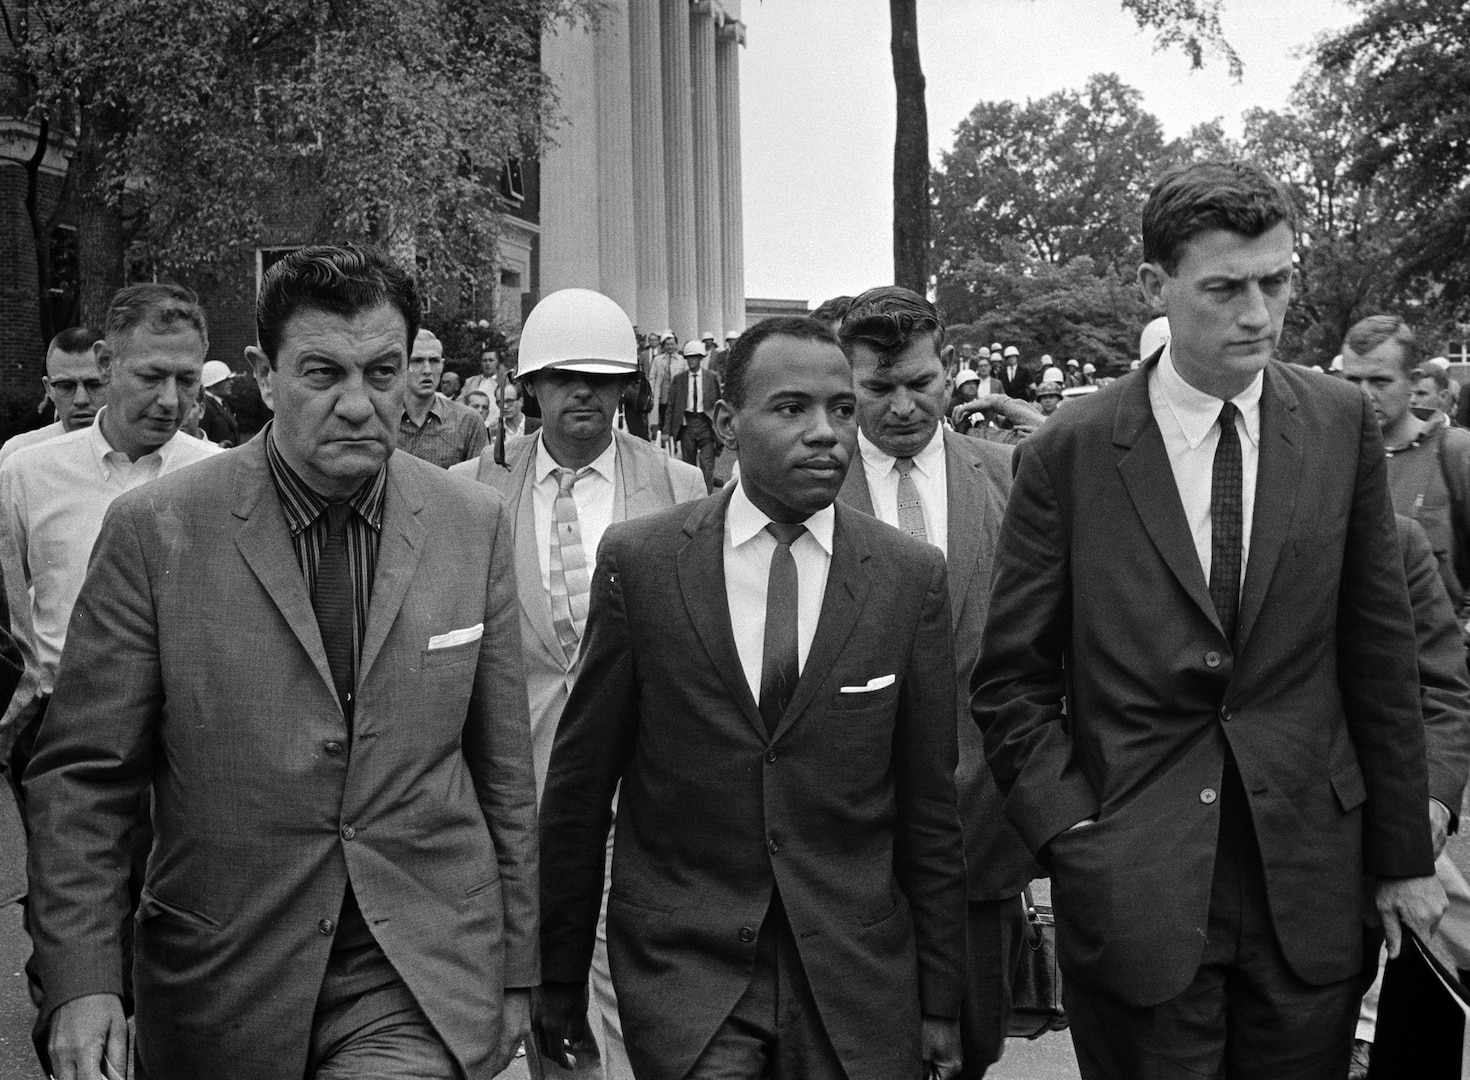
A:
[678,488,764,739]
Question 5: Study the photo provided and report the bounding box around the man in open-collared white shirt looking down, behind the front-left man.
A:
[0,284,219,1040]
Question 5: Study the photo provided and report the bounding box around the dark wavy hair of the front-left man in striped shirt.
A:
[256,244,423,367]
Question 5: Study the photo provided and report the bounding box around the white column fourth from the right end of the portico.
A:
[628,0,669,334]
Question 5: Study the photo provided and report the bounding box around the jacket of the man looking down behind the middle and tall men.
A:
[838,431,1041,901]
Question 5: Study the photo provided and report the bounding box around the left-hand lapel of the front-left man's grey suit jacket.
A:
[234,438,337,696]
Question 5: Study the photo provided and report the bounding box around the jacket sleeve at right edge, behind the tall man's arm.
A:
[1395,514,1470,821]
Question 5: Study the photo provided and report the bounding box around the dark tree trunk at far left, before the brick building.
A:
[72,93,126,329]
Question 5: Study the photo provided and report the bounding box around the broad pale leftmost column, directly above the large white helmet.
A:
[541,22,603,295]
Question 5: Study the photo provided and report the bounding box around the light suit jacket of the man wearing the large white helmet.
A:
[450,431,706,795]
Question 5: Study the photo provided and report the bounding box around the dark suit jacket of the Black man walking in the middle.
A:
[541,489,964,1080]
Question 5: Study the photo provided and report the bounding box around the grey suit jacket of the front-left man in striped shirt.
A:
[26,436,538,1080]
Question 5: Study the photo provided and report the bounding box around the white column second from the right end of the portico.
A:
[689,0,725,341]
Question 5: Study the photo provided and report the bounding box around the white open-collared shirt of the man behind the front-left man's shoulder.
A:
[0,408,221,705]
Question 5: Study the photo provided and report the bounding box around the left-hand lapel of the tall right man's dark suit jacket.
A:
[1113,365,1223,633]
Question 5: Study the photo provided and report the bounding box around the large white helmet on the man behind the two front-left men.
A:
[516,289,638,379]
